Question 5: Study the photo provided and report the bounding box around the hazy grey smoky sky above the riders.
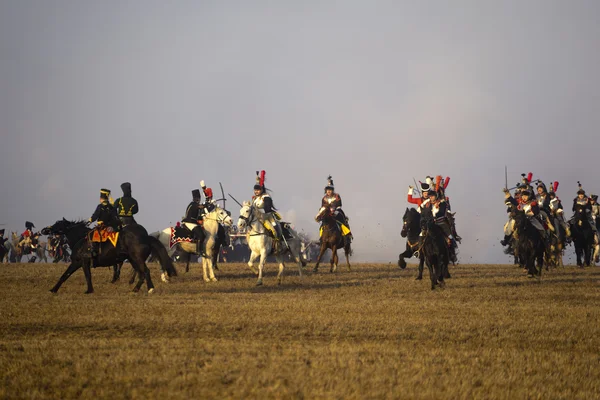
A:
[0,0,600,263]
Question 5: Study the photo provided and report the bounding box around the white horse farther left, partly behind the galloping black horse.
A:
[150,207,233,282]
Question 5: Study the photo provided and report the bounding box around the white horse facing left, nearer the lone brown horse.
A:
[238,201,303,286]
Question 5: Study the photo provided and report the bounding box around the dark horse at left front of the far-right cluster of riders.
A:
[511,207,546,278]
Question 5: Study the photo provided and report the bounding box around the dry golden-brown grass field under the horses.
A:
[0,264,600,399]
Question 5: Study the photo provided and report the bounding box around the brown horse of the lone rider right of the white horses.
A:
[313,207,352,272]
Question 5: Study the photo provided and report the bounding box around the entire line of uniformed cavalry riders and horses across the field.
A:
[0,171,600,293]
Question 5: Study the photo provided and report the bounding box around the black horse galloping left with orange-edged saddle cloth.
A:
[42,218,177,293]
